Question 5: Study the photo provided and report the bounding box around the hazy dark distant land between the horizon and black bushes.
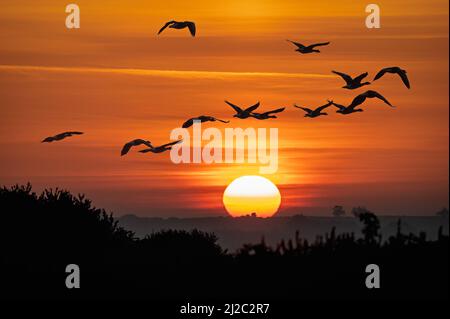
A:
[116,211,449,252]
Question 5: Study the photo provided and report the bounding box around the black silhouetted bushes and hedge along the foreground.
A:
[0,185,449,302]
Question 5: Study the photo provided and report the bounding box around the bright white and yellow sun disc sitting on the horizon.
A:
[223,175,281,217]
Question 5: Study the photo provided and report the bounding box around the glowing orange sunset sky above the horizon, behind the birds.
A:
[0,0,449,217]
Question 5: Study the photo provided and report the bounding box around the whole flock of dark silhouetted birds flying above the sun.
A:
[42,20,411,156]
